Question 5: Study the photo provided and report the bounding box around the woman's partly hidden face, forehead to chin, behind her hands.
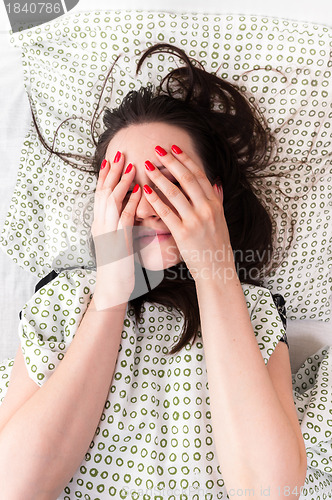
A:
[106,122,204,271]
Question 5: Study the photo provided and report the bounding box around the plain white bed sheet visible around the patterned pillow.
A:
[0,0,332,371]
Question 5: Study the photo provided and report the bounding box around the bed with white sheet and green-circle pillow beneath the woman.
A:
[0,2,332,499]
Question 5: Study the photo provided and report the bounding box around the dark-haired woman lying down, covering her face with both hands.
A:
[0,44,307,500]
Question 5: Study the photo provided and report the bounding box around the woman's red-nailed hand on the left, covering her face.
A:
[91,154,141,310]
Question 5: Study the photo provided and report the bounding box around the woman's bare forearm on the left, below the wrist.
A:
[0,299,126,500]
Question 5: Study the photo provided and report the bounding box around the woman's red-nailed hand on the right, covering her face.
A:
[143,146,236,284]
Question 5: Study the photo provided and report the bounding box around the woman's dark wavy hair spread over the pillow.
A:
[31,43,290,354]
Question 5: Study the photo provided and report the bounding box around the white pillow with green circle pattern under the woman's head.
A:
[0,10,332,321]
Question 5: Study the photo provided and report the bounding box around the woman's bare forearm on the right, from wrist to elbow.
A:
[196,270,307,500]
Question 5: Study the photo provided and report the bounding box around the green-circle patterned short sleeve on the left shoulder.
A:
[18,268,96,385]
